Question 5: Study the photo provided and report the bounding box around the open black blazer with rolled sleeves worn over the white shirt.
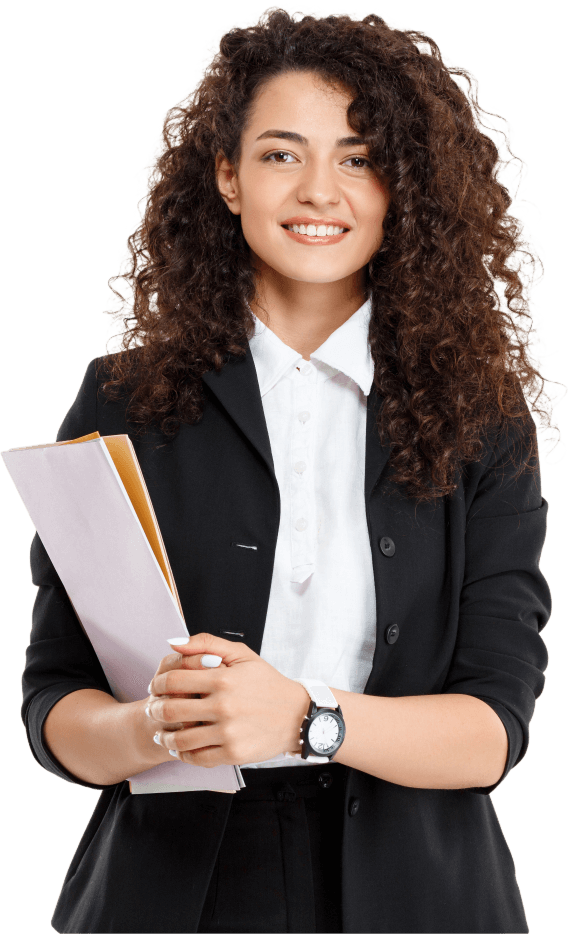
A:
[21,349,552,934]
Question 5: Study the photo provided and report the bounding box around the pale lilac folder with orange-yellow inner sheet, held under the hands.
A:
[0,431,245,794]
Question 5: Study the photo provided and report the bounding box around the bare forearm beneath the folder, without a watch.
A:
[43,688,172,785]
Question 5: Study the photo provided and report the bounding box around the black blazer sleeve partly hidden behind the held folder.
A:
[20,357,112,789]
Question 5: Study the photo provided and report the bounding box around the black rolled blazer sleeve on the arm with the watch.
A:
[443,403,552,795]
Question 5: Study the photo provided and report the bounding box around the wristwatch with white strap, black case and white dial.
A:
[292,678,345,762]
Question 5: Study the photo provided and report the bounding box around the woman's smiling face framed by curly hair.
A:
[217,73,388,292]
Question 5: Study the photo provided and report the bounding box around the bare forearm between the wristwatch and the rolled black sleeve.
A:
[330,686,508,788]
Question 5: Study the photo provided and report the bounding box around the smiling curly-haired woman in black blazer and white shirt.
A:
[22,9,552,934]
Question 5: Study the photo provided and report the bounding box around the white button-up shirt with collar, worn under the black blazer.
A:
[241,300,377,768]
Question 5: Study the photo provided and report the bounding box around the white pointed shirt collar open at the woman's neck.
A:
[249,298,375,396]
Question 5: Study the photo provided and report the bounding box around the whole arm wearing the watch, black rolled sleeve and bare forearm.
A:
[324,406,552,793]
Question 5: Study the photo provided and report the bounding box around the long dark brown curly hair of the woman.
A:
[101,6,566,502]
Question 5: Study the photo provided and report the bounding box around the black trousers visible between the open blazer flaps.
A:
[197,762,347,934]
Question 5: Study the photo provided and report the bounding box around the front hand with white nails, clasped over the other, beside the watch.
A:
[144,633,309,769]
